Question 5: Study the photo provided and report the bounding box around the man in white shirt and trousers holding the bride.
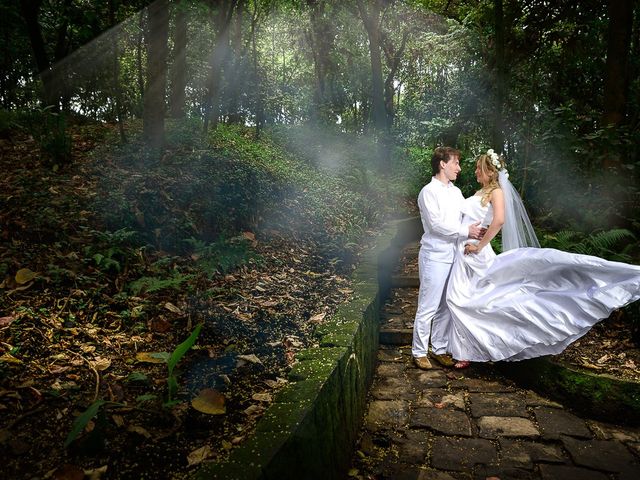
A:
[411,147,484,370]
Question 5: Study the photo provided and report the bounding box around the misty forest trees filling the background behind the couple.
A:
[0,0,640,231]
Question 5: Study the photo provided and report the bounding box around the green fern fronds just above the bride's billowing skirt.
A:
[541,228,637,262]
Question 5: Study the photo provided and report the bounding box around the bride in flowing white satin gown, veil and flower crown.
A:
[446,150,640,368]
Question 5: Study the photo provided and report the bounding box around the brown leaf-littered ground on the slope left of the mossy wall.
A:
[0,128,368,479]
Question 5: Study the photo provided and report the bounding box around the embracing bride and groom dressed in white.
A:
[412,147,640,370]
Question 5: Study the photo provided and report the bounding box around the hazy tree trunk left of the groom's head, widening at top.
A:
[358,0,387,133]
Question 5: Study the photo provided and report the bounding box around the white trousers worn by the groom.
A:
[411,248,453,357]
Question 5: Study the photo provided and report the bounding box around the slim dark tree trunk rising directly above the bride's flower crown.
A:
[491,0,507,152]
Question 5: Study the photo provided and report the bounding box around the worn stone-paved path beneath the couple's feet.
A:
[345,246,640,480]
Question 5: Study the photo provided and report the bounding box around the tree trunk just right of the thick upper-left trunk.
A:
[169,0,188,118]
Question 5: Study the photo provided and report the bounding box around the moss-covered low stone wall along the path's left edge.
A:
[195,219,416,480]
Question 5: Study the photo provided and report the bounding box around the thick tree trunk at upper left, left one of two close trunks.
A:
[142,0,169,148]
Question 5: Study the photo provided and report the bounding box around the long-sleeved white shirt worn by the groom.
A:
[418,177,469,263]
